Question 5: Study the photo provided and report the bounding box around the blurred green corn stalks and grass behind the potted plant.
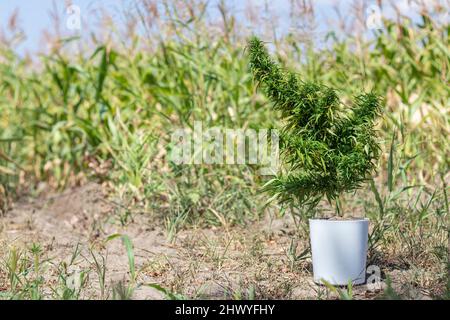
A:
[0,2,450,225]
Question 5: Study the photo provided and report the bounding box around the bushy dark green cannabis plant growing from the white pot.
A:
[249,37,380,214]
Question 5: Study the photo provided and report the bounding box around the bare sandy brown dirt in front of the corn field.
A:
[0,183,436,299]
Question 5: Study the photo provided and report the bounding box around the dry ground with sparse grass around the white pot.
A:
[0,184,446,299]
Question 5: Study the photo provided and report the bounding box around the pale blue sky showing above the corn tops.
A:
[0,0,446,51]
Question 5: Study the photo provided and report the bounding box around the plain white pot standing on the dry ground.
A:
[309,219,369,286]
